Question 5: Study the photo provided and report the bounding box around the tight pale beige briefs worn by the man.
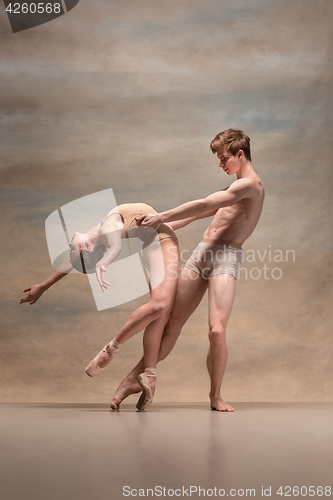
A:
[185,238,243,279]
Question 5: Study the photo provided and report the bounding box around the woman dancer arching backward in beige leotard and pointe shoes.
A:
[20,203,181,410]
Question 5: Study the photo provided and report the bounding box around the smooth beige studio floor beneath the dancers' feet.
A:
[0,403,333,500]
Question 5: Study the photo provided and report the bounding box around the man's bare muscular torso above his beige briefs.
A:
[204,174,265,245]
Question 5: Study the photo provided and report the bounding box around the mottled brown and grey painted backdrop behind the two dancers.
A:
[0,0,333,402]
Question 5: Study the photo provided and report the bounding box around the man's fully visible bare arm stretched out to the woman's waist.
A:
[137,179,252,229]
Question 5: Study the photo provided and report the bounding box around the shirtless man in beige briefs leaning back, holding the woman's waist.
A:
[110,129,264,411]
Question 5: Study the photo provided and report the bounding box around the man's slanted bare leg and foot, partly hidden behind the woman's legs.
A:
[111,267,208,409]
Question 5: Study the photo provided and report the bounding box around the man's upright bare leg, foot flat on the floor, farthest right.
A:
[207,274,236,411]
